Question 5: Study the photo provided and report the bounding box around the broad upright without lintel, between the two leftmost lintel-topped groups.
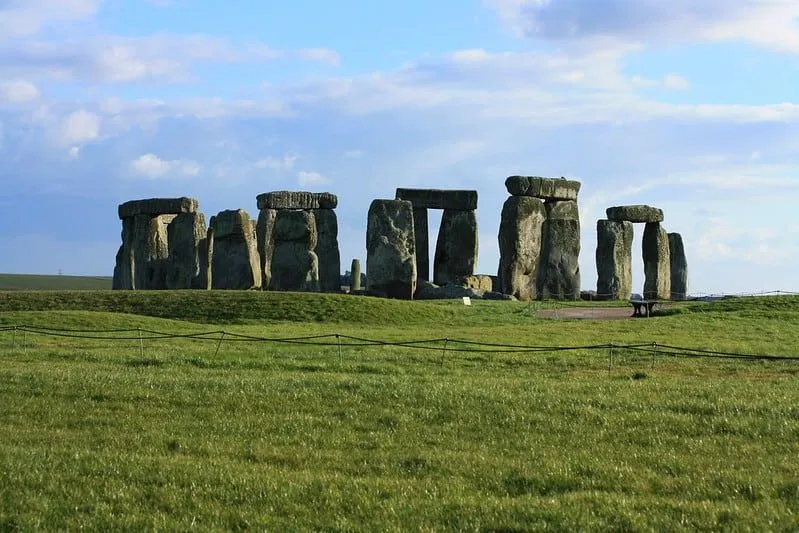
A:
[209,209,262,290]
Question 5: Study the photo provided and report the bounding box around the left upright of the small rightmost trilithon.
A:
[596,220,634,300]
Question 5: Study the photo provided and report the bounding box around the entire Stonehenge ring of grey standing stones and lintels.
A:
[113,182,688,301]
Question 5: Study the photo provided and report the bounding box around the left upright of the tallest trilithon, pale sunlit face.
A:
[494,196,546,300]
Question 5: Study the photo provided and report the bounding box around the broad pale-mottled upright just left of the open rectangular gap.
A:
[366,200,416,300]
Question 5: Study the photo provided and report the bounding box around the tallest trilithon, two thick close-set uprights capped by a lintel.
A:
[498,176,581,300]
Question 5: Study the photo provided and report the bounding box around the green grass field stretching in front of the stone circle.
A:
[0,291,799,531]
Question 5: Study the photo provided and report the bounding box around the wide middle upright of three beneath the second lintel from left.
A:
[269,210,319,291]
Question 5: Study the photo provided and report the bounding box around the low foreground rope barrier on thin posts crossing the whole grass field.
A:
[0,325,799,367]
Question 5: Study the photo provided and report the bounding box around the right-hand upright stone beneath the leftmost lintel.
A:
[166,213,209,289]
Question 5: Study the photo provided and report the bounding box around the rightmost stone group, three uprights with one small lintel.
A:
[596,205,688,300]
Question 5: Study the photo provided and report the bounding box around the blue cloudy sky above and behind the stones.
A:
[0,0,799,293]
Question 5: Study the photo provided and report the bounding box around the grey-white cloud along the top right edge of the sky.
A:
[486,0,799,53]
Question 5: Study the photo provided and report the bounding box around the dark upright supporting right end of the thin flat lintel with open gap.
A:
[433,209,478,285]
